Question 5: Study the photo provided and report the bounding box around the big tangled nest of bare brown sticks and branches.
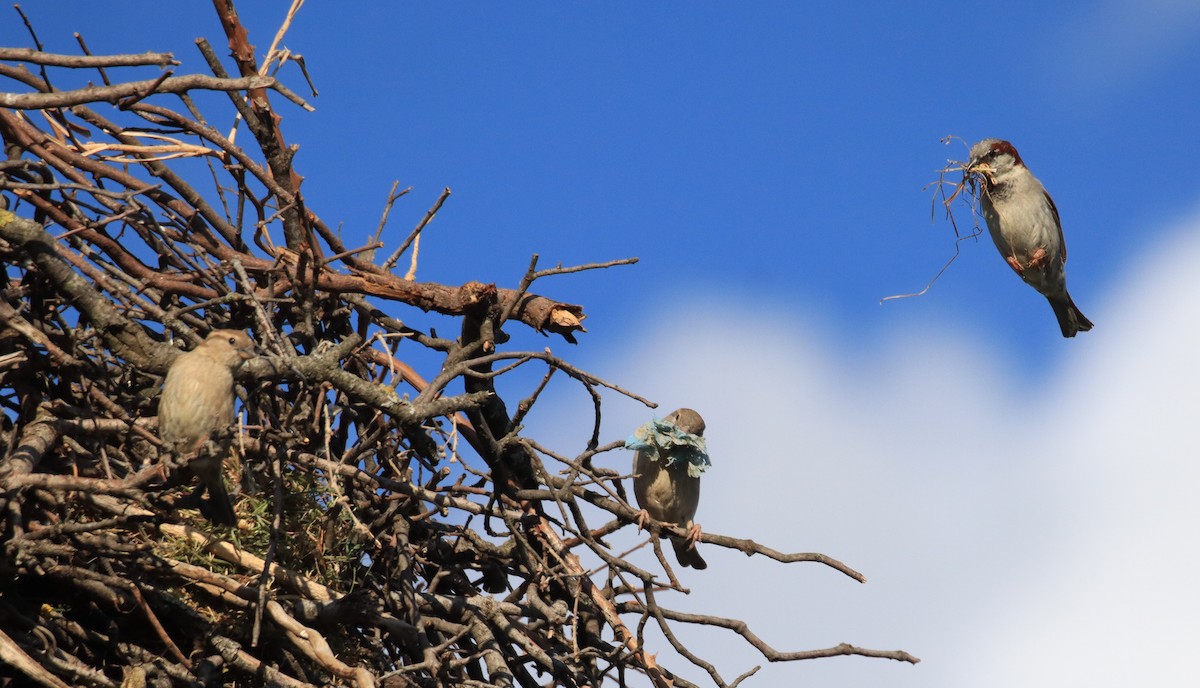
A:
[0,2,917,687]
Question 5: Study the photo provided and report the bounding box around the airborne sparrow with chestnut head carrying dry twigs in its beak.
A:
[967,138,1092,337]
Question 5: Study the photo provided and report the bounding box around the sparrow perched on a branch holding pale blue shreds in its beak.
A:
[625,408,712,569]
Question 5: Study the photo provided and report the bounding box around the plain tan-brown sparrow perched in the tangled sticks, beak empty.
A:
[158,330,254,526]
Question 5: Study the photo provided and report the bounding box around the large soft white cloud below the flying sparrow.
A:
[532,206,1200,688]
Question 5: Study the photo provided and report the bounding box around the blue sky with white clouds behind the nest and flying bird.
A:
[9,0,1200,687]
